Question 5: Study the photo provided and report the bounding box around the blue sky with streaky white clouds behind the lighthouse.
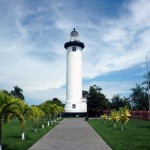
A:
[0,0,150,105]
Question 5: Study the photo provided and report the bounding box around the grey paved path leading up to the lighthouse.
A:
[28,118,111,150]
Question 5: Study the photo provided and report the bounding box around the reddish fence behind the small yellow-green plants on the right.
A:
[103,110,150,120]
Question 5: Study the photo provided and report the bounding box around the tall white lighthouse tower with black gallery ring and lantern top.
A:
[64,29,87,115]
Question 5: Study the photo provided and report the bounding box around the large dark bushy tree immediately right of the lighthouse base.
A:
[87,85,109,116]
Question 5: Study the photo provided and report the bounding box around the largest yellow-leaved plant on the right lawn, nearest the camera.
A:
[119,107,131,131]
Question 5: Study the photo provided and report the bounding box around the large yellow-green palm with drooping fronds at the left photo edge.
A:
[0,91,24,150]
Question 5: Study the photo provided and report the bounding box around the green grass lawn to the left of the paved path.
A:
[2,120,60,150]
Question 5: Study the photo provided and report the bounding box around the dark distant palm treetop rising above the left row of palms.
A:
[11,85,24,100]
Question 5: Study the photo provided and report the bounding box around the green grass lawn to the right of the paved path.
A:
[88,119,150,150]
